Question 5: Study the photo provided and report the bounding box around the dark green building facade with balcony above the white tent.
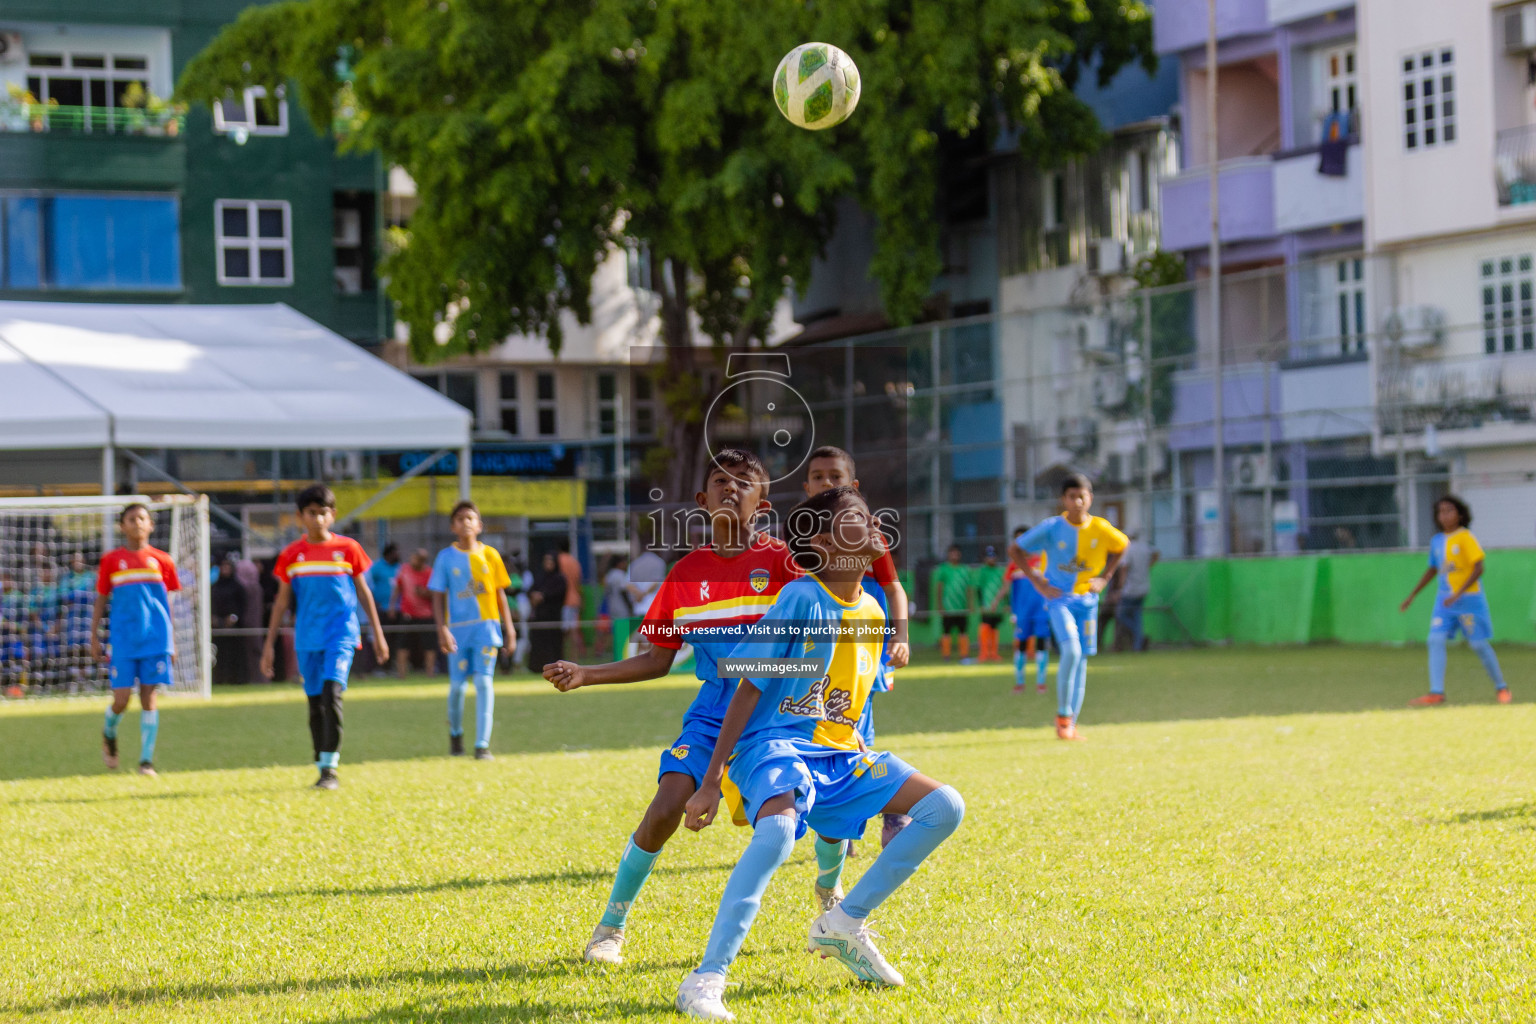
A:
[0,0,390,345]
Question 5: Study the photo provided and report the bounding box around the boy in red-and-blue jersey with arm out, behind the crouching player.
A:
[544,448,799,964]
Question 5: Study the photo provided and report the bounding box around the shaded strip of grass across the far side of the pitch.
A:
[0,646,1536,786]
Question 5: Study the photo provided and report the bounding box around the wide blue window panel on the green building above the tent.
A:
[0,193,181,292]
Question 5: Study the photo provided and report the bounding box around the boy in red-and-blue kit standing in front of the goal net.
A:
[91,502,181,777]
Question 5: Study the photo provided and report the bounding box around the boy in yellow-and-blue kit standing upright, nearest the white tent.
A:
[427,502,518,761]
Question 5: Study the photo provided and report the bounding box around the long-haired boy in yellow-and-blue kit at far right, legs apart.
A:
[1398,494,1510,708]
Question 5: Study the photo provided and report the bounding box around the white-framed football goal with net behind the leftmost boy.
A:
[0,494,212,697]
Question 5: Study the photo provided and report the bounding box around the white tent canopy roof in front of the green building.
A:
[0,302,472,450]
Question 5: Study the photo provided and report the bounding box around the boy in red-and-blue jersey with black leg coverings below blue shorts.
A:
[261,484,389,789]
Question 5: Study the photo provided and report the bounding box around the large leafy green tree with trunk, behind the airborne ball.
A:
[178,0,1154,494]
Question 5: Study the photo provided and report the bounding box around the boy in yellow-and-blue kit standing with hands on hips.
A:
[1015,473,1130,740]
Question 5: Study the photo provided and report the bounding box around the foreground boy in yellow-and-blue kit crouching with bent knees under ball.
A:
[676,487,965,1021]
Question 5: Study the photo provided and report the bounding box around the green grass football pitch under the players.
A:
[0,648,1536,1022]
